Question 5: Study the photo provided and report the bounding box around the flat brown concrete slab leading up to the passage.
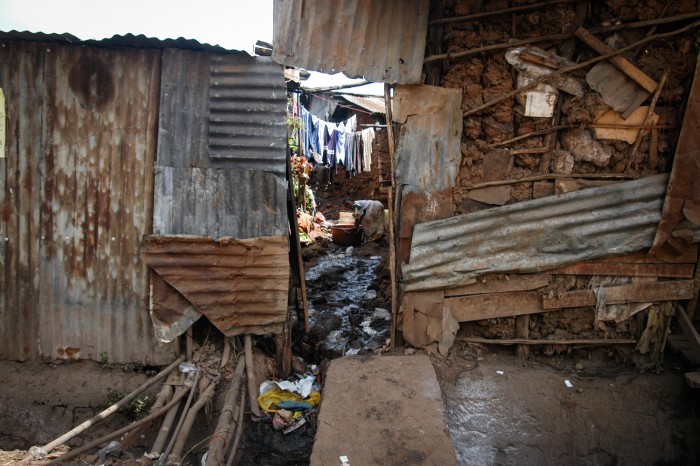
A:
[311,355,457,466]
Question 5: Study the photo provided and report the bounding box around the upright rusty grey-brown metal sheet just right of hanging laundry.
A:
[393,85,462,270]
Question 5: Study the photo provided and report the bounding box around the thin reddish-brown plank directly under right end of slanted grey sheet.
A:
[550,261,694,278]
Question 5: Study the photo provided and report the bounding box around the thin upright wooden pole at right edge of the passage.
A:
[384,84,399,349]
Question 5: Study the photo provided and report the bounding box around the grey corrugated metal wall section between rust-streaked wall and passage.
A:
[153,49,289,239]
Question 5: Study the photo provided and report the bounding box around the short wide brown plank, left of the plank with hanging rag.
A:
[445,291,547,322]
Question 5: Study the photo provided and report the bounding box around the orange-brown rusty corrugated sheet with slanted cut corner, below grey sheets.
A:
[141,235,289,336]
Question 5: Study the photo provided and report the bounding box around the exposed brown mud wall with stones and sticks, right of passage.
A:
[400,0,700,351]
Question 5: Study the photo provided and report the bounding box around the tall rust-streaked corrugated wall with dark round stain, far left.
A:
[0,40,178,364]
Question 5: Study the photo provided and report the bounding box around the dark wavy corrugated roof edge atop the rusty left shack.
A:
[0,31,248,56]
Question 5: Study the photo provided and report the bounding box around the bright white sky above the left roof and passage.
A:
[0,0,383,95]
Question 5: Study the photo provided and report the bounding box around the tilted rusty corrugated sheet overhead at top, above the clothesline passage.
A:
[272,0,430,84]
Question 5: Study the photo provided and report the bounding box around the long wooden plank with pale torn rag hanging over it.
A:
[542,280,693,310]
